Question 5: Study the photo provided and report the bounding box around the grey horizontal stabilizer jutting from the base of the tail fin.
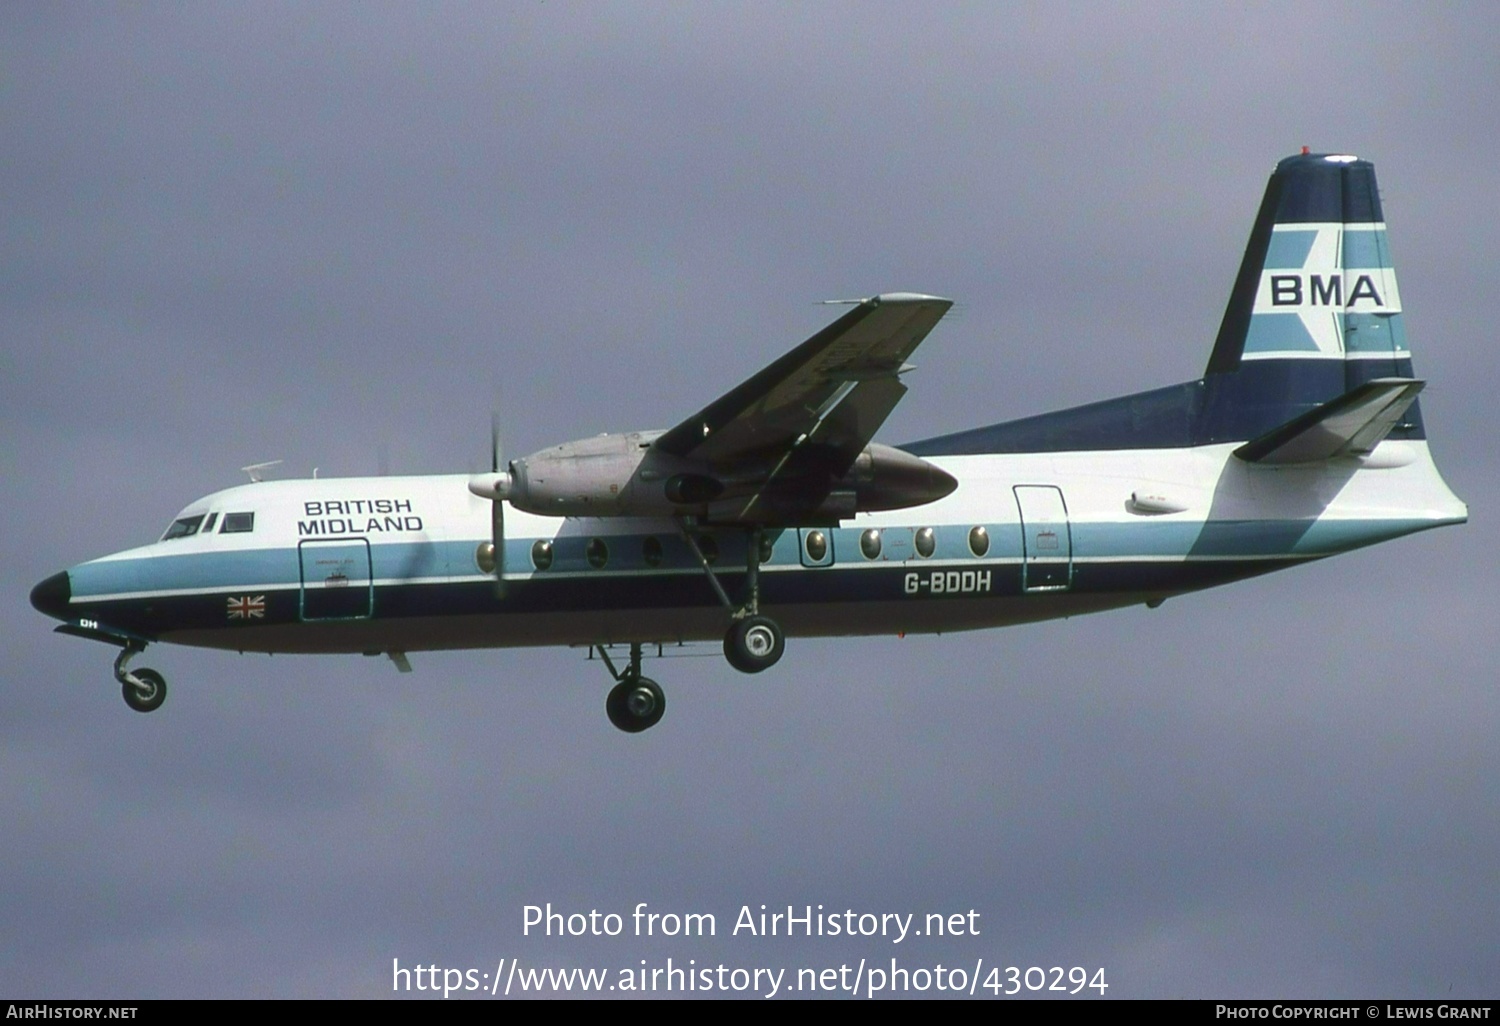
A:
[1235,378,1427,464]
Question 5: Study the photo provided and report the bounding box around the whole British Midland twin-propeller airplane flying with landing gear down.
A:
[32,147,1469,734]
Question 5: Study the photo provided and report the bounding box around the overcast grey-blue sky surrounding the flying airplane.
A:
[0,3,1500,998]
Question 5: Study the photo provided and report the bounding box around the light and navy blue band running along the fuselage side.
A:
[61,519,1430,648]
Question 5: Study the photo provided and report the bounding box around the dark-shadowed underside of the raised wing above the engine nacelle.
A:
[653,293,953,477]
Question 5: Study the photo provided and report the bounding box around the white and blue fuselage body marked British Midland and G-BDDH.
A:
[61,440,1467,653]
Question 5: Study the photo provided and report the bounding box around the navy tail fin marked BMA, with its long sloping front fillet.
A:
[903,153,1427,462]
